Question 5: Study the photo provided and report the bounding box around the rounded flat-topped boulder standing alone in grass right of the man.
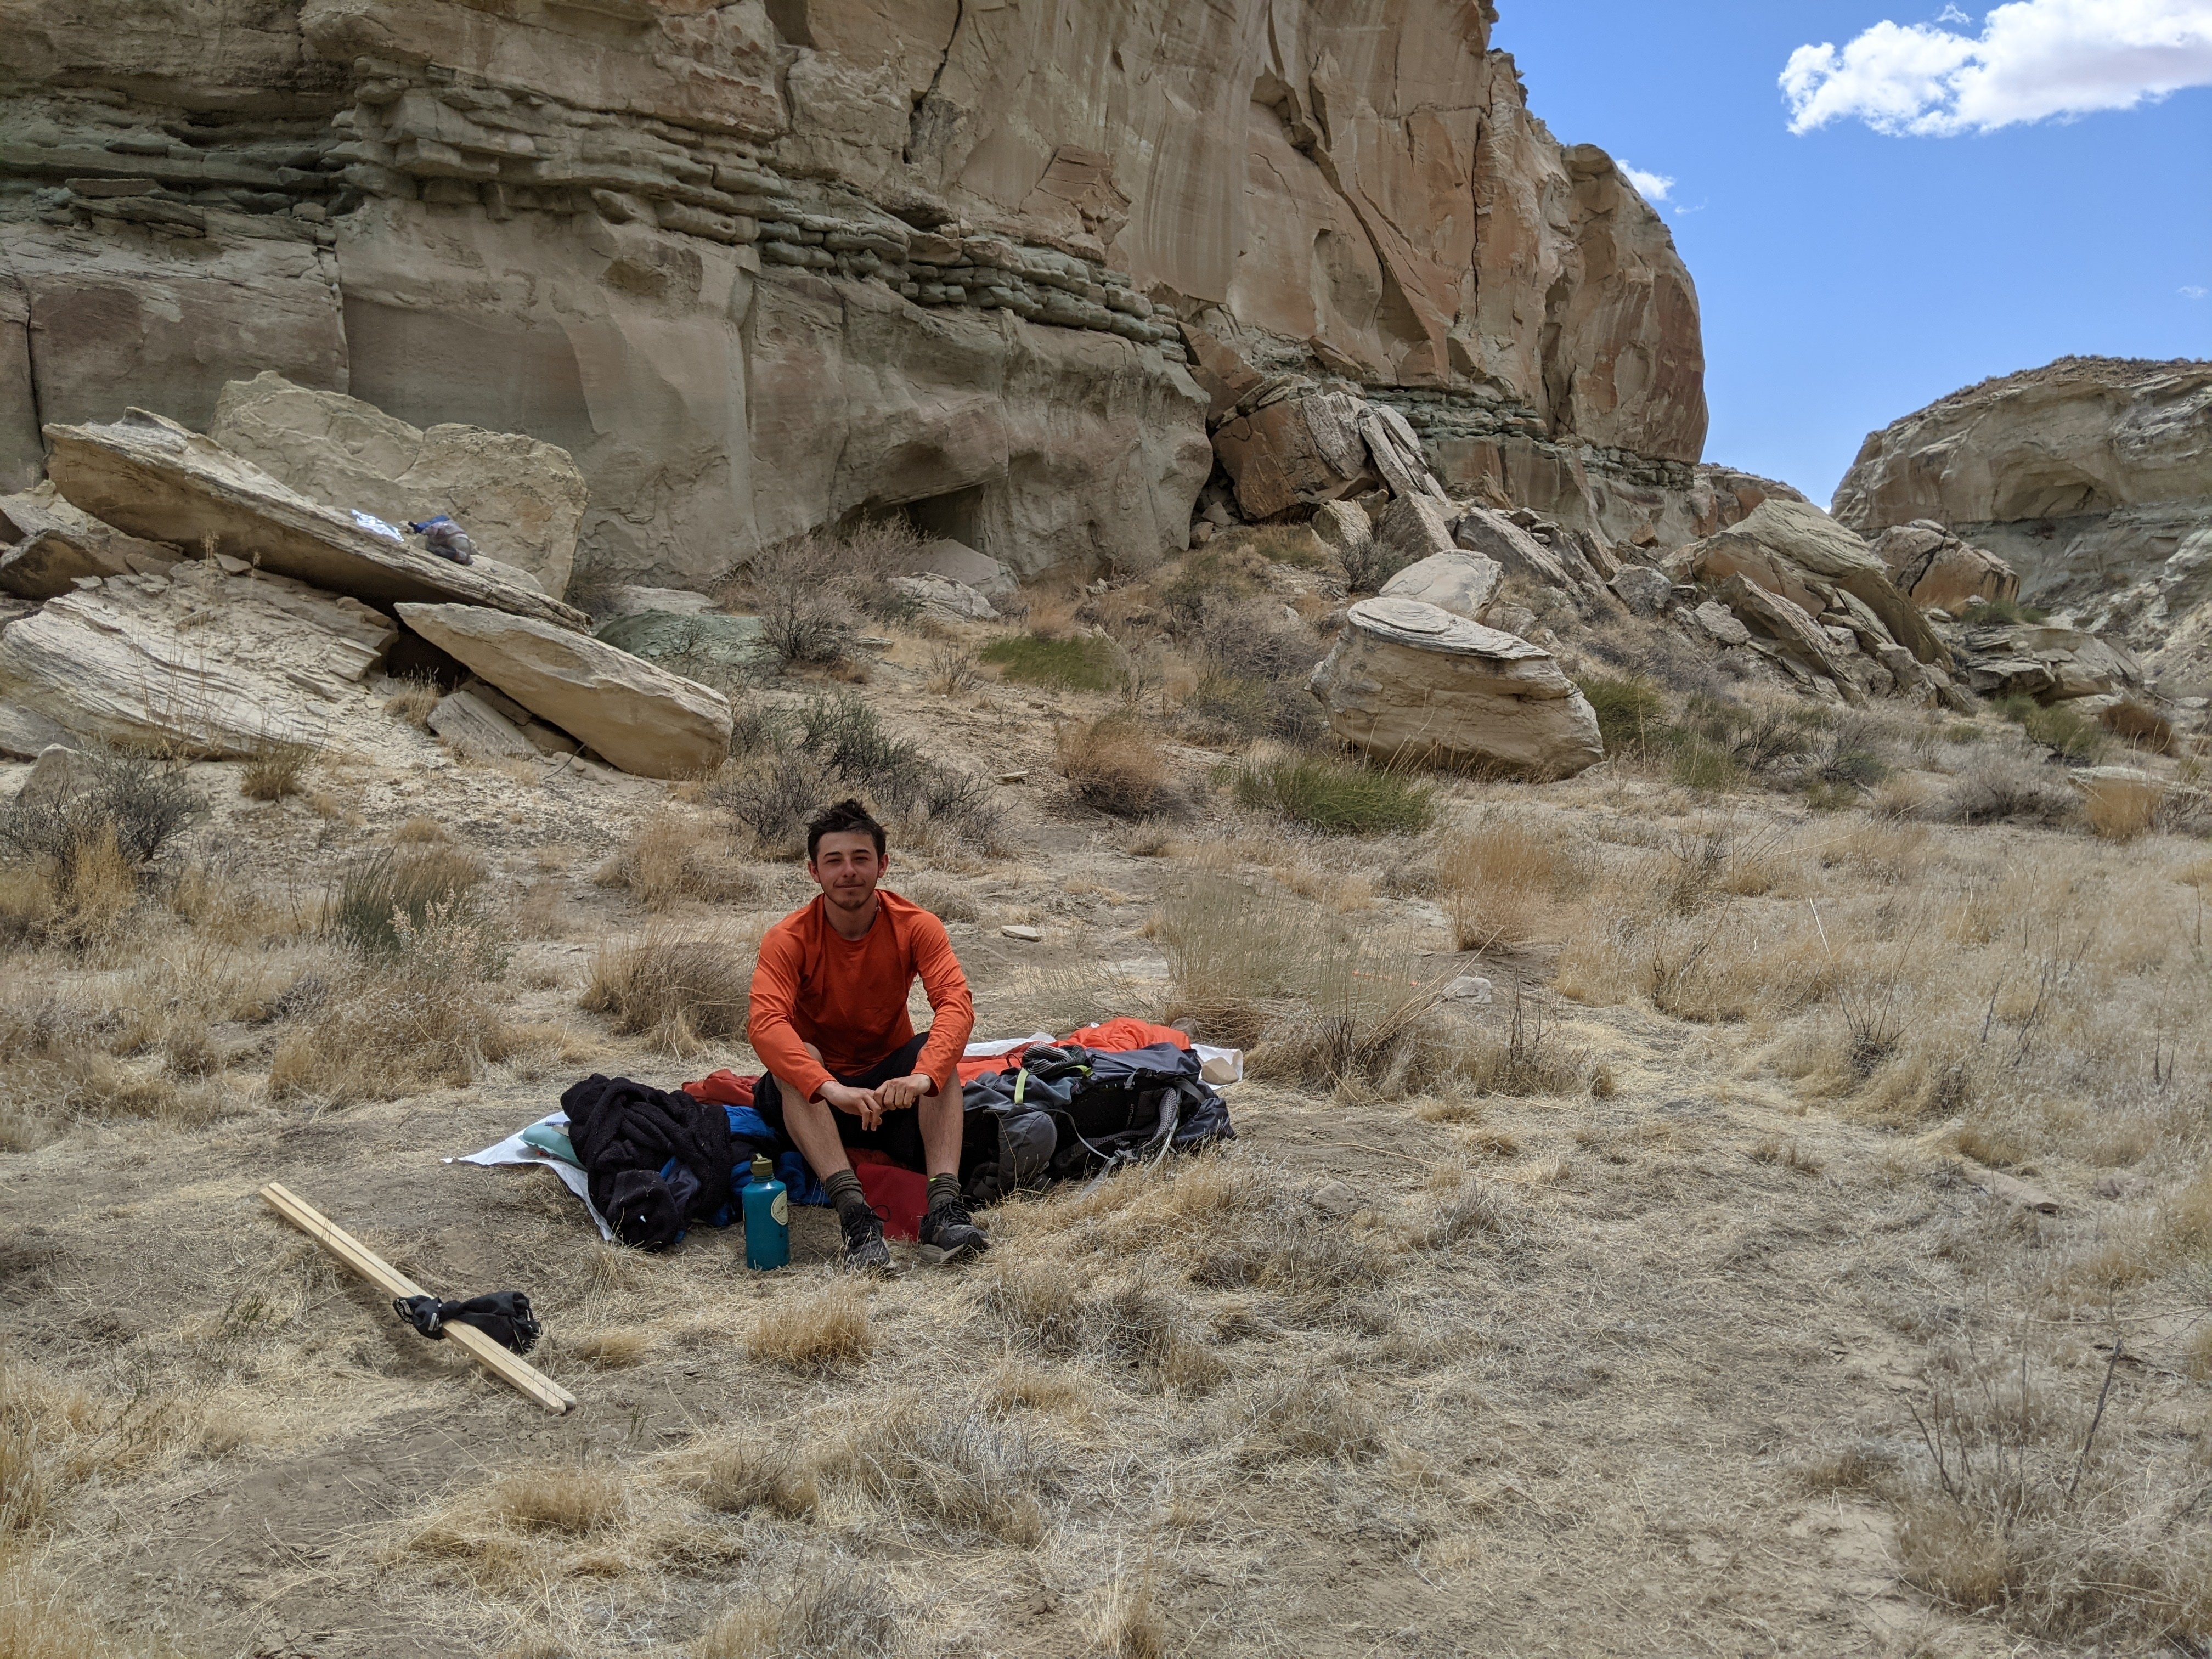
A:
[1310,597,1606,778]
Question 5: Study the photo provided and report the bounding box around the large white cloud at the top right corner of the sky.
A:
[1781,0,2212,137]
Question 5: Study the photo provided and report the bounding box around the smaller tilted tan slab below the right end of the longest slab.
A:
[398,604,730,778]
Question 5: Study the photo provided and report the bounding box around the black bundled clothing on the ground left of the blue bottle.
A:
[560,1073,739,1250]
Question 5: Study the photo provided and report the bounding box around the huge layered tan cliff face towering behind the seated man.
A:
[0,0,1707,582]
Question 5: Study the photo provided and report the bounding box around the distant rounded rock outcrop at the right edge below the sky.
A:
[1836,358,2212,686]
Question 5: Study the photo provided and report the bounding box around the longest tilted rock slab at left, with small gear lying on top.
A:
[47,409,589,628]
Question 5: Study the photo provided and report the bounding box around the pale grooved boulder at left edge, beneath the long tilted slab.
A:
[0,560,398,759]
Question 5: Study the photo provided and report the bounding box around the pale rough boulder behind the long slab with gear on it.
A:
[208,369,591,600]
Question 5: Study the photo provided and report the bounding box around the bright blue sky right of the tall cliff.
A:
[1493,0,2212,504]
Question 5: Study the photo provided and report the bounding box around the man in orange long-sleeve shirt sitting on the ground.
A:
[752,801,991,1267]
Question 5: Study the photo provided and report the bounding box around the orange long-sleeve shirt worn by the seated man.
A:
[750,887,975,1099]
